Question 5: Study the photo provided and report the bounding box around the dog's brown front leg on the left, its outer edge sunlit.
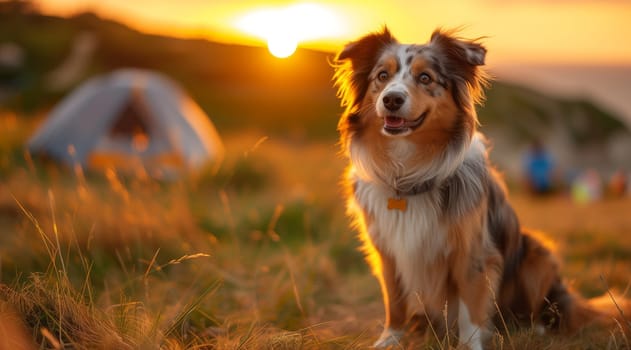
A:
[374,253,407,348]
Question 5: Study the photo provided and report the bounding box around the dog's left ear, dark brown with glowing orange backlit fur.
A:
[334,27,397,111]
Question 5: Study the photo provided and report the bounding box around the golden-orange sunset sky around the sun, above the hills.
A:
[38,0,631,64]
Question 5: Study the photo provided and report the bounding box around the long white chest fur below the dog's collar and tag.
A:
[355,179,451,311]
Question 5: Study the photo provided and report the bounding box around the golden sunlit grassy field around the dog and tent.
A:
[0,115,631,349]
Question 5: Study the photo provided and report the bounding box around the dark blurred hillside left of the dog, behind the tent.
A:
[0,6,339,136]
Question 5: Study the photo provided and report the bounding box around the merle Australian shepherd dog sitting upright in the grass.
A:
[334,28,621,349]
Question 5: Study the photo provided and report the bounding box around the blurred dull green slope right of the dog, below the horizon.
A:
[479,82,631,176]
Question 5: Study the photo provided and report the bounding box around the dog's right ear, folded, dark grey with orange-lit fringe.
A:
[429,29,487,108]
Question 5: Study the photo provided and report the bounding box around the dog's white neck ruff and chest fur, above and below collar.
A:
[349,135,485,312]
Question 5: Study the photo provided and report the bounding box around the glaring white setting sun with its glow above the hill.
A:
[236,3,344,58]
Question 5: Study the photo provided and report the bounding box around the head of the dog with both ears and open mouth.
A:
[335,28,486,146]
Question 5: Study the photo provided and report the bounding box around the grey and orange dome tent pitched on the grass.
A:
[28,69,223,177]
